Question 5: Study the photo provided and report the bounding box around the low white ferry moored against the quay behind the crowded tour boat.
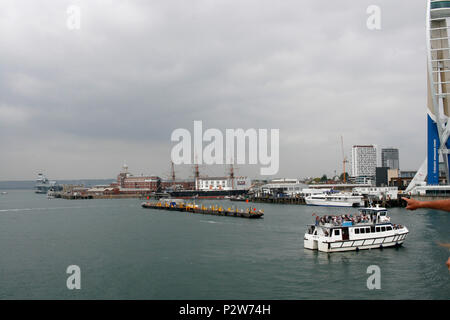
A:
[305,193,364,207]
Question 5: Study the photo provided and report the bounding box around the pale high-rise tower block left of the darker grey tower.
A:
[352,145,377,183]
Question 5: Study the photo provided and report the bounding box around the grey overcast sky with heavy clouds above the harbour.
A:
[0,0,426,180]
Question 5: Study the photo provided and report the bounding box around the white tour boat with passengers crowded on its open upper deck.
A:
[304,206,409,252]
